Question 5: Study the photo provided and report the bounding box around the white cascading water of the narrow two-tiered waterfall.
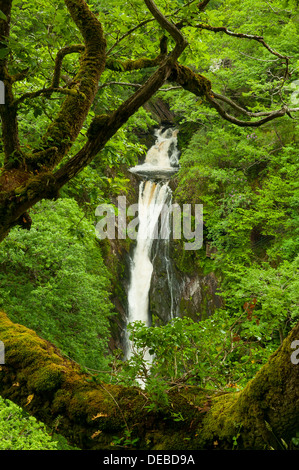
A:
[126,129,179,363]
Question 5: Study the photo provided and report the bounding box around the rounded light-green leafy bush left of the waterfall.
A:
[0,199,112,368]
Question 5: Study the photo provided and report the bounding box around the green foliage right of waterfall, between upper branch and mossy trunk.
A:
[172,113,299,385]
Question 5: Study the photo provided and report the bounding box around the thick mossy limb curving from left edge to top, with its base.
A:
[0,0,106,240]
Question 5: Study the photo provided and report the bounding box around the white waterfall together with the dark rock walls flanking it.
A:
[106,123,222,360]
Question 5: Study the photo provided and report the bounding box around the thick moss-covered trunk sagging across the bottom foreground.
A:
[0,313,299,450]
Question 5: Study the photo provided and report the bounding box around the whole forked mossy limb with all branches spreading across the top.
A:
[0,0,299,241]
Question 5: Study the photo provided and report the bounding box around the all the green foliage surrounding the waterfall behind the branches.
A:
[0,0,299,449]
